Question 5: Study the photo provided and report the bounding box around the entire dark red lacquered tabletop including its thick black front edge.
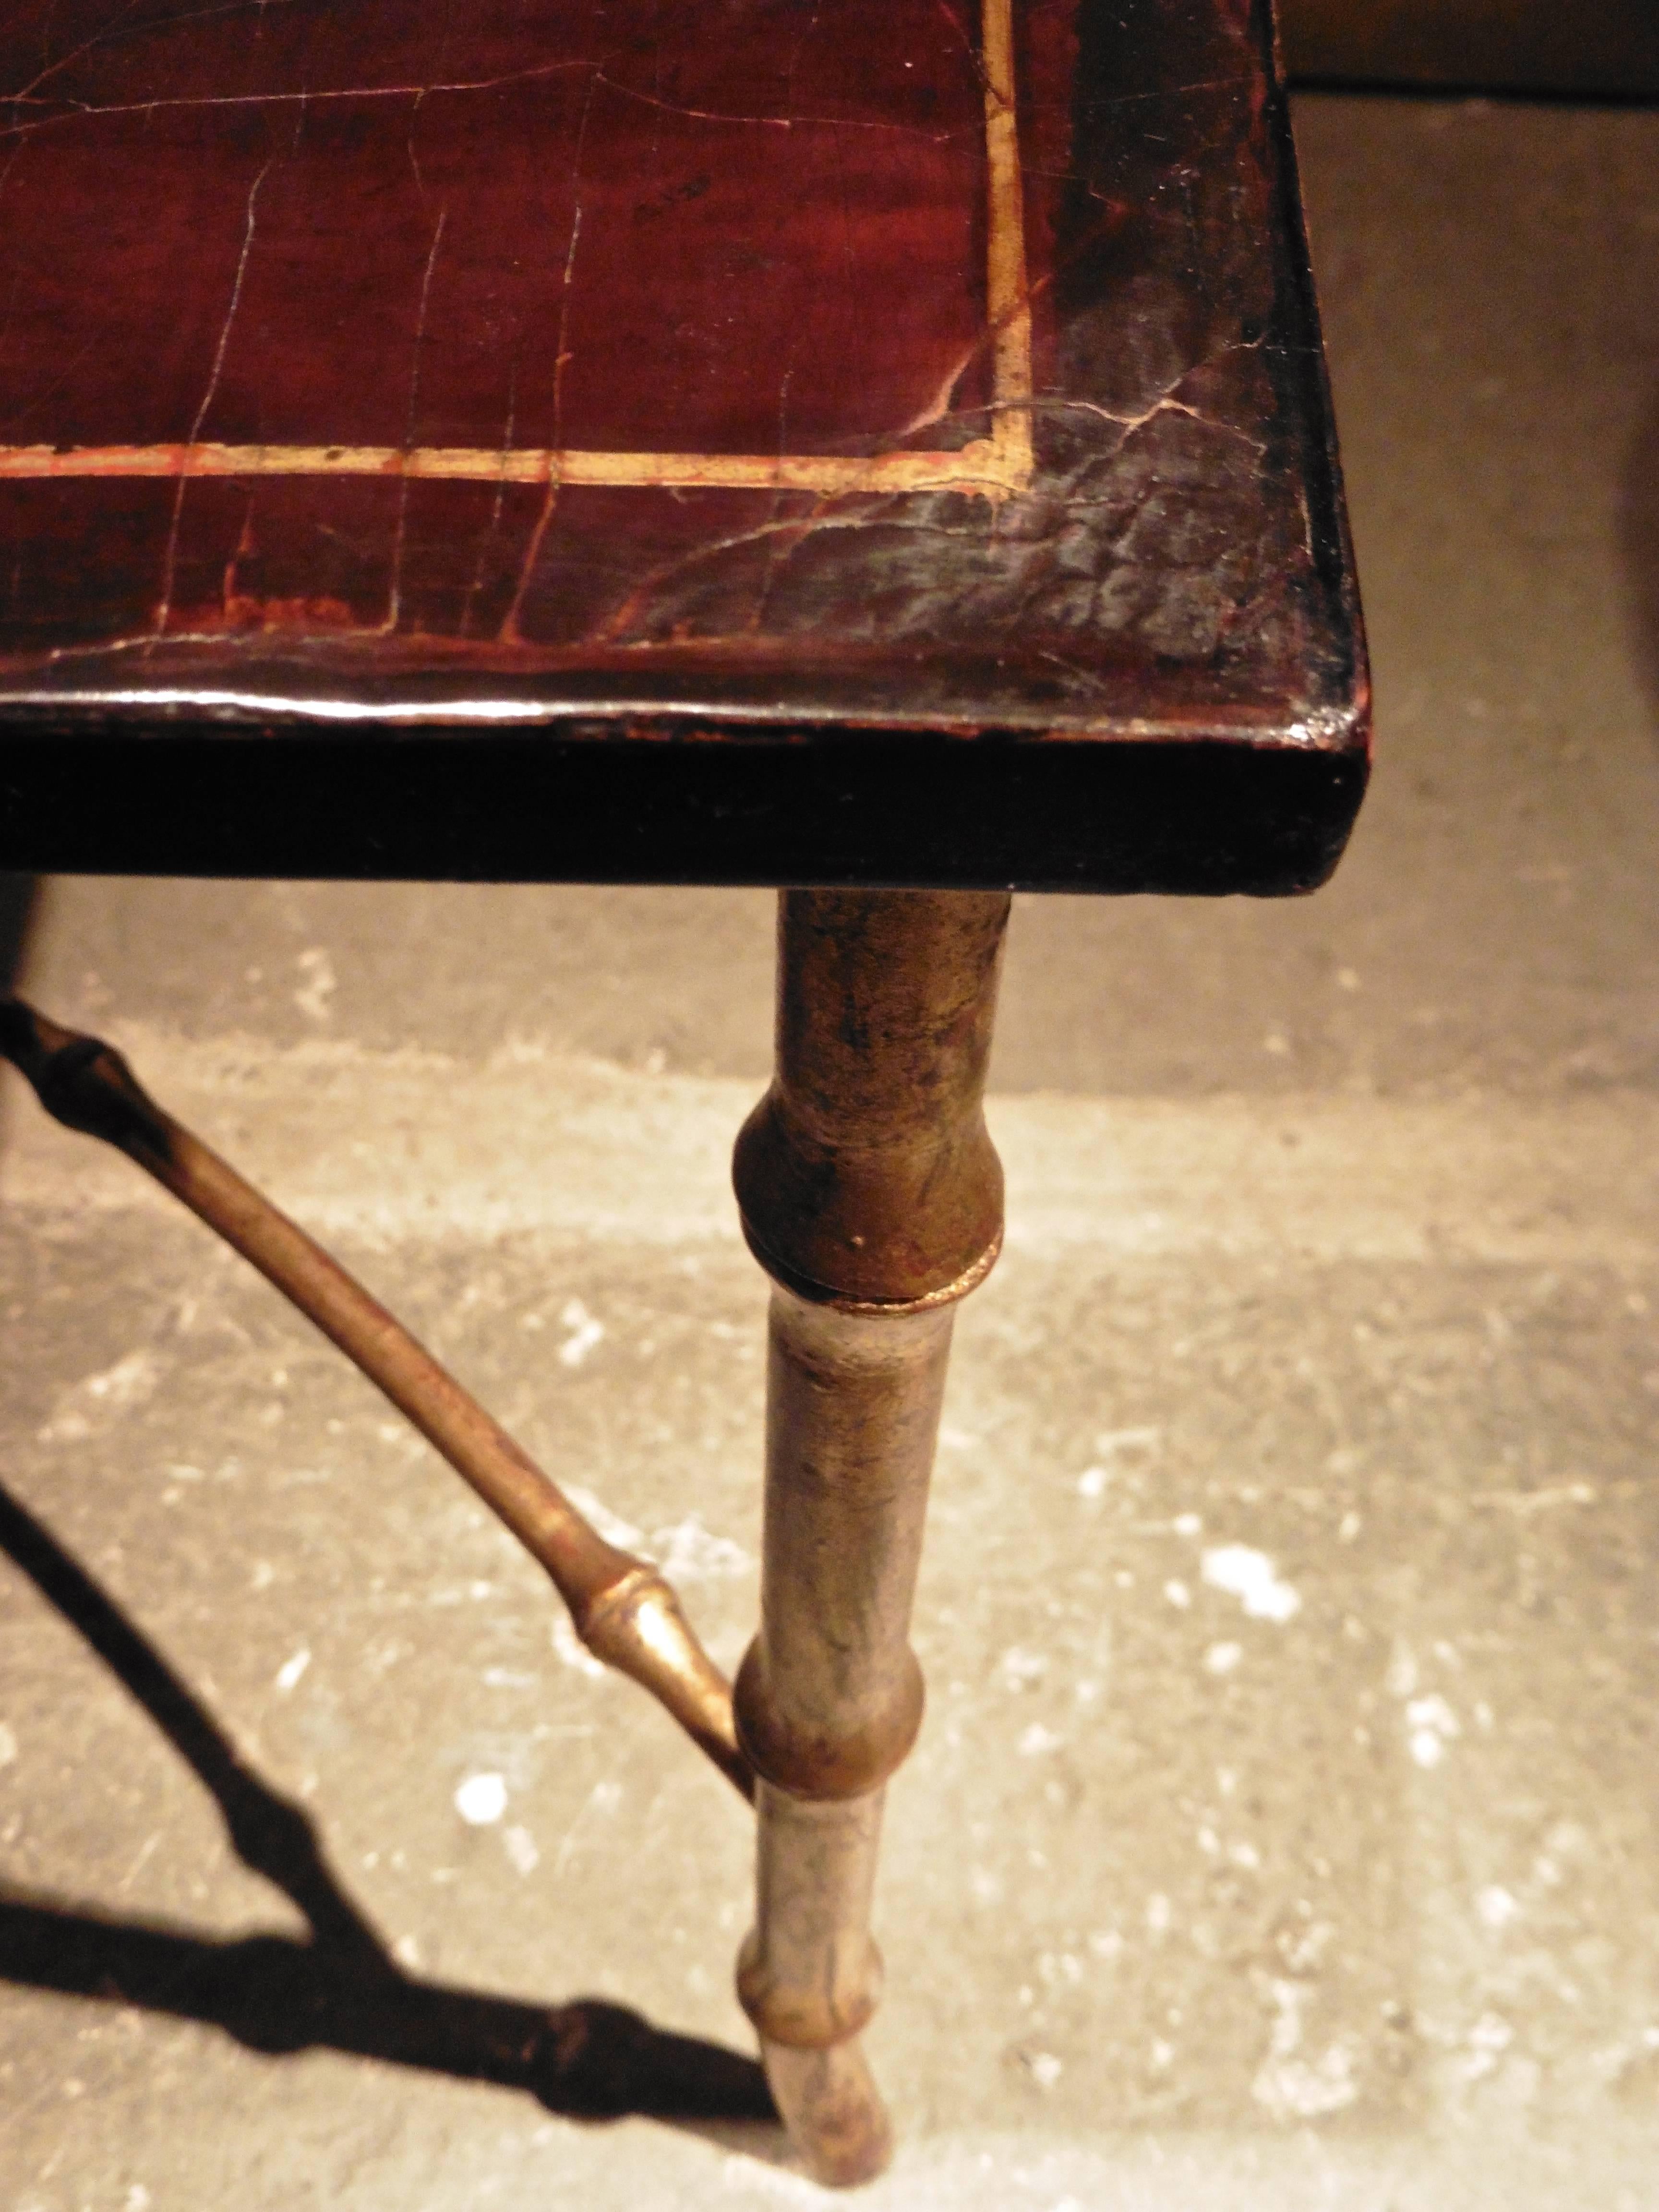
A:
[0,0,1367,891]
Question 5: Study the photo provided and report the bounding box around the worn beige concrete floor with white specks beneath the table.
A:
[0,97,1659,2212]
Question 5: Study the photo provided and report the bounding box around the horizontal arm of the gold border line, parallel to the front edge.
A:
[0,438,1020,493]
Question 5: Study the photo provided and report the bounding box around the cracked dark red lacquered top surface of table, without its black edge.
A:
[0,0,1343,712]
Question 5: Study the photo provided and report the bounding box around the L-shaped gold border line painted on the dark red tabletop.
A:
[0,0,1033,498]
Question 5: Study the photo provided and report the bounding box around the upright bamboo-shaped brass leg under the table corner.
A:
[734,891,1009,2183]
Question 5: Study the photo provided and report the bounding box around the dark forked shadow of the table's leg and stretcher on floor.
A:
[0,1489,783,2157]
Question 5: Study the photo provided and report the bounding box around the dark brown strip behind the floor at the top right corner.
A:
[1278,0,1659,97]
